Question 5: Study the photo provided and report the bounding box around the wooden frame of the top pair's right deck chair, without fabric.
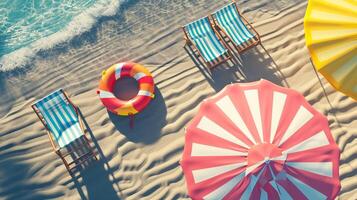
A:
[211,0,261,53]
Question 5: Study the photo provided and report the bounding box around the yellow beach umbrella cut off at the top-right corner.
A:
[304,0,357,100]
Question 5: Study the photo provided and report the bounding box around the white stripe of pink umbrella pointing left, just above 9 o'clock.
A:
[191,143,247,156]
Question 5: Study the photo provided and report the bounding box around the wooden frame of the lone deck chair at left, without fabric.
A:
[31,89,98,175]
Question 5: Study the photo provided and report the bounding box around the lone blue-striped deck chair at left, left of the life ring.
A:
[32,89,97,175]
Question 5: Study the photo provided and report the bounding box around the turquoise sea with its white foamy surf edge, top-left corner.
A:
[0,0,123,71]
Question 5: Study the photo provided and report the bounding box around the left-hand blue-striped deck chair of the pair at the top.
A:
[183,17,232,68]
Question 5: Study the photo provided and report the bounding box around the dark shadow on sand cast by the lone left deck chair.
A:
[68,111,122,200]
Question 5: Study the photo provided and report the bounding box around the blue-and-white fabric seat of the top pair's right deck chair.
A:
[213,3,254,45]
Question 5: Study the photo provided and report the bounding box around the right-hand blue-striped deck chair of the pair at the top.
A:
[212,2,260,52]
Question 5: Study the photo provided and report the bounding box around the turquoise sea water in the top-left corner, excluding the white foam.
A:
[0,0,96,56]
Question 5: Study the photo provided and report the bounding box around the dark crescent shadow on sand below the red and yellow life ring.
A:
[108,87,167,144]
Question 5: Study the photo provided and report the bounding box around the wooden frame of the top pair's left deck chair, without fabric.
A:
[182,16,233,70]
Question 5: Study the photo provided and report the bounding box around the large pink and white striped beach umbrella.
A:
[181,80,340,200]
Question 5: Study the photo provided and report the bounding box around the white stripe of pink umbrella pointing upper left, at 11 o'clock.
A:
[216,96,256,144]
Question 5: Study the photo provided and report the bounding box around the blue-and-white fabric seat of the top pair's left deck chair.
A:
[185,17,227,62]
